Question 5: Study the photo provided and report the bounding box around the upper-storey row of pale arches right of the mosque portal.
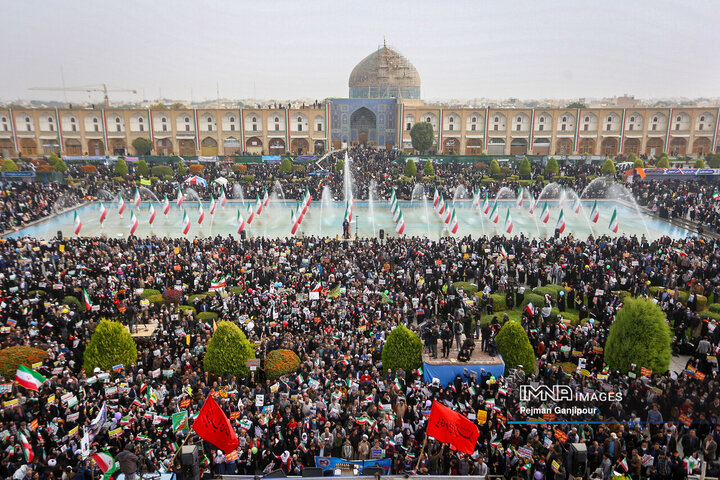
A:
[404,112,715,132]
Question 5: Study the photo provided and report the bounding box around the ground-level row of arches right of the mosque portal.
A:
[442,137,712,156]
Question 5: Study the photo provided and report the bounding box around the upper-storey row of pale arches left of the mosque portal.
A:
[0,112,325,133]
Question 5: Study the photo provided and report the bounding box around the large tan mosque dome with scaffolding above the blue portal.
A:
[348,45,420,99]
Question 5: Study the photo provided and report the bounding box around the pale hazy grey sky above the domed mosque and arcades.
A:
[0,0,720,101]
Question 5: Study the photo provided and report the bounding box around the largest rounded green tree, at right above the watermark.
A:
[605,298,672,375]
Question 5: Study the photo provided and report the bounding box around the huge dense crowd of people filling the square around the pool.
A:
[0,147,720,480]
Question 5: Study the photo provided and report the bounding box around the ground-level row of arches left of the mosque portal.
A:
[0,137,325,157]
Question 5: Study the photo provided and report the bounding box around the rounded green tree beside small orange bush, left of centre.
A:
[203,320,255,377]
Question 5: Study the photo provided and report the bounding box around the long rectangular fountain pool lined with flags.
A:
[9,201,689,239]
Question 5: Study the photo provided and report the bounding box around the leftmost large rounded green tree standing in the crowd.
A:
[83,319,137,373]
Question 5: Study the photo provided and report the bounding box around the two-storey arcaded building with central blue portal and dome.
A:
[0,46,720,157]
